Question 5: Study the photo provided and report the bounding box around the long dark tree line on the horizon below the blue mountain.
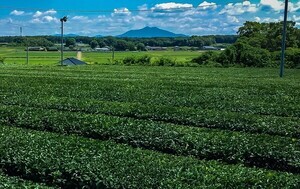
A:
[0,35,237,51]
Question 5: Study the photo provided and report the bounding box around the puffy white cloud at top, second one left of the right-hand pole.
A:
[219,1,259,15]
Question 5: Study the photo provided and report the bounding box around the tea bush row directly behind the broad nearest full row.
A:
[0,106,300,173]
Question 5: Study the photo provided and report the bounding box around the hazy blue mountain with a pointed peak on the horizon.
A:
[117,27,186,38]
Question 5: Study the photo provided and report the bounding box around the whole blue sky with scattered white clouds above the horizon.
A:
[0,0,300,36]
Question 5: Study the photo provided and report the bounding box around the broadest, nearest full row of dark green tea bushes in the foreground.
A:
[0,126,300,188]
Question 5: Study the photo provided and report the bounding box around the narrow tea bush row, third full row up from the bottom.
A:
[0,94,300,138]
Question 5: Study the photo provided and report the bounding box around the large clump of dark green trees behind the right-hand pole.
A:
[193,21,300,68]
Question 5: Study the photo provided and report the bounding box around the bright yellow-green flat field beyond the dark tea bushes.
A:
[0,47,202,65]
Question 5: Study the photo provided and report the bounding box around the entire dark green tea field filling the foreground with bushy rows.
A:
[0,65,300,188]
